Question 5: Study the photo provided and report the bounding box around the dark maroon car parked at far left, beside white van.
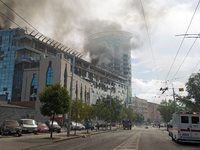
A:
[0,120,22,136]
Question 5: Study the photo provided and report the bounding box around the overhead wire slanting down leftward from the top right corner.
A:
[165,0,200,80]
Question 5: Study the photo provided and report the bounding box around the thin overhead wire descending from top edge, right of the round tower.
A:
[140,0,159,80]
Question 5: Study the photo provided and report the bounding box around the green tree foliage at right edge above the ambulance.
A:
[176,73,200,112]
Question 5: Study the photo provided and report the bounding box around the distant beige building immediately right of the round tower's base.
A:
[132,96,148,121]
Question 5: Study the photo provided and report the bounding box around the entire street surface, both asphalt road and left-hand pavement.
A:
[0,127,200,150]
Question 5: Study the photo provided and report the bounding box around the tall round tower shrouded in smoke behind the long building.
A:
[87,31,132,106]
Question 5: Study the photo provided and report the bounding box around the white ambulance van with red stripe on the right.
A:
[169,112,200,143]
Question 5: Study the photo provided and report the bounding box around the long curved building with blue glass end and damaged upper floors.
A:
[0,28,128,104]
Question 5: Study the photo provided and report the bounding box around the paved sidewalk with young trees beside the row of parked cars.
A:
[0,128,116,150]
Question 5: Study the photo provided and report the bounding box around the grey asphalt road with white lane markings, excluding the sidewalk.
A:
[29,128,200,150]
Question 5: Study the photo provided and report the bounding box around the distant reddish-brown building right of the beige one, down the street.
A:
[147,102,162,124]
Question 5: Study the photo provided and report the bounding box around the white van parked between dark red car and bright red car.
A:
[19,119,37,134]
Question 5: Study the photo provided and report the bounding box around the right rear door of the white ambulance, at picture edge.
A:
[191,114,200,138]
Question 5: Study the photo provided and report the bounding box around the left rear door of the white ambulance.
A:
[180,114,191,137]
